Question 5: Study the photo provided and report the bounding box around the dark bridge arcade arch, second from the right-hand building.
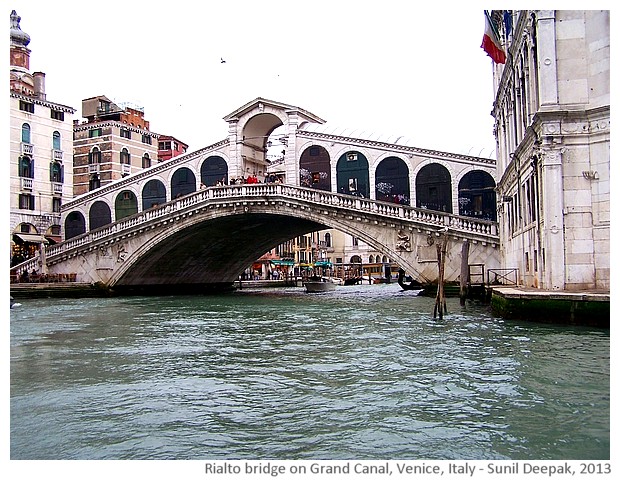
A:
[415,163,452,213]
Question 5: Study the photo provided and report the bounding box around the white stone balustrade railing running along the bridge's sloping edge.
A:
[11,183,497,274]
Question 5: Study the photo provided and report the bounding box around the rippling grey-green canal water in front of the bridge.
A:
[10,284,610,459]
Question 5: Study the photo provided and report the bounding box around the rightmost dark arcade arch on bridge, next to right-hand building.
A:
[458,170,497,222]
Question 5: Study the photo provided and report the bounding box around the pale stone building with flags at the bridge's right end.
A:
[490,10,610,290]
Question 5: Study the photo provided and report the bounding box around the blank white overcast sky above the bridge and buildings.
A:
[5,0,520,158]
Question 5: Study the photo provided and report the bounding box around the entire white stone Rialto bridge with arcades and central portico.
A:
[12,98,499,291]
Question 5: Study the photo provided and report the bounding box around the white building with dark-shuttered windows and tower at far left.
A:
[9,10,75,264]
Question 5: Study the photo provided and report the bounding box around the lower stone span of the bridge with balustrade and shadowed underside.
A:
[26,184,498,291]
